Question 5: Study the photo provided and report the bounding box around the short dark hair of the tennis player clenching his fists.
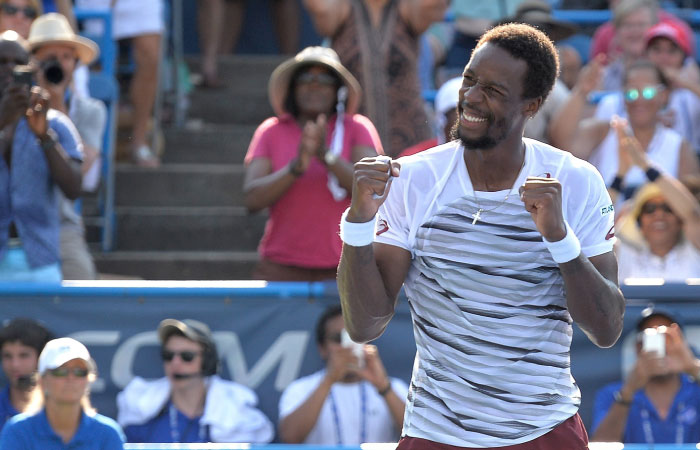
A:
[472,23,559,102]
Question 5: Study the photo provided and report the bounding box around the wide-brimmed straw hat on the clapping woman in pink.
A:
[267,47,362,116]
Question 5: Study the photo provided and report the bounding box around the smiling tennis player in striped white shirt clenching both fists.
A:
[338,24,624,450]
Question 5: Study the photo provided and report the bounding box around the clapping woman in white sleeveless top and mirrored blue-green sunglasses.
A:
[552,60,700,199]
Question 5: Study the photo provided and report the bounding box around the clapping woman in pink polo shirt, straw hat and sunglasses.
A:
[243,47,382,281]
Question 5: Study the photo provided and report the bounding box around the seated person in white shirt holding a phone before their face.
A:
[279,306,408,445]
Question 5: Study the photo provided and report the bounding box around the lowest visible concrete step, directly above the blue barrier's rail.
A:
[93,251,258,280]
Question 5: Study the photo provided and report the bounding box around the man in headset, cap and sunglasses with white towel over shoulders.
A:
[117,319,275,444]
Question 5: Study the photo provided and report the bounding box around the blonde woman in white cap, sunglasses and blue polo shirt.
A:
[0,338,124,450]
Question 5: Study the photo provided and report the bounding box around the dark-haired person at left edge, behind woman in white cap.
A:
[0,318,53,429]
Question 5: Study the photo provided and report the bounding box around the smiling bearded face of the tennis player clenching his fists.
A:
[452,43,541,150]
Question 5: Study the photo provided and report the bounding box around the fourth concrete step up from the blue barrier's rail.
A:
[163,122,257,164]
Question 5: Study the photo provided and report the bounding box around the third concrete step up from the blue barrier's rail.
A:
[115,164,244,207]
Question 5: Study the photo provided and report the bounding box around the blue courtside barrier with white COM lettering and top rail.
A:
[0,279,700,440]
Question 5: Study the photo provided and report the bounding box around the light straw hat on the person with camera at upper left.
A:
[27,13,100,64]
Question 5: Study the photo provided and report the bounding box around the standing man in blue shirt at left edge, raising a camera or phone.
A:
[0,31,82,283]
